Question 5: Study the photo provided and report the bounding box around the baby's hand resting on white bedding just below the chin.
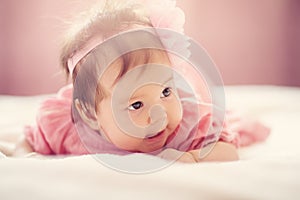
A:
[158,148,197,163]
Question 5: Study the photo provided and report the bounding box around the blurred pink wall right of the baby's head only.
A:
[180,0,300,85]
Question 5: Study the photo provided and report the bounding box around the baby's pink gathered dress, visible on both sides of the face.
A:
[25,85,270,155]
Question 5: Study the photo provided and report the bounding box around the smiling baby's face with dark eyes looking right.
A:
[97,51,182,152]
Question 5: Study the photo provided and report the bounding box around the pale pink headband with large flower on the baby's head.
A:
[68,0,185,76]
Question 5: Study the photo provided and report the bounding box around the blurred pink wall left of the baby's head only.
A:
[0,0,95,95]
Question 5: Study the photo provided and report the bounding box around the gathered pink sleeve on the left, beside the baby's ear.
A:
[25,85,88,154]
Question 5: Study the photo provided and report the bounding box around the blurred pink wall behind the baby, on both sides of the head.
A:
[0,0,300,95]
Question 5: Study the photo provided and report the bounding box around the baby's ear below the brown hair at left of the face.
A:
[74,99,99,130]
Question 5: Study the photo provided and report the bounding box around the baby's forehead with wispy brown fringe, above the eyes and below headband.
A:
[100,49,173,93]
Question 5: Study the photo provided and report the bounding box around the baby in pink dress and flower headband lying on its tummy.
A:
[21,0,269,162]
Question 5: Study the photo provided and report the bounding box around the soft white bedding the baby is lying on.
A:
[0,86,300,200]
